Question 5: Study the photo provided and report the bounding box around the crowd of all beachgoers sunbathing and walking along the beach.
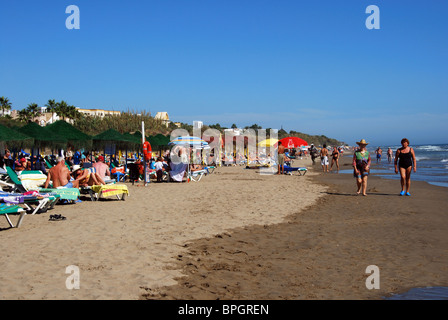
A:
[0,139,417,196]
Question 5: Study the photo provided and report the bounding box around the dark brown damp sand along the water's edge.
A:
[142,157,448,300]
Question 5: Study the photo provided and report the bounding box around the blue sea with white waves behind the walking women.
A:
[340,144,448,187]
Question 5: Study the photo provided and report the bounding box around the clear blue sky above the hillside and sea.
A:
[0,0,448,145]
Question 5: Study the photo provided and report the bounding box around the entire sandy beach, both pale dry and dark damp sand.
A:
[0,158,448,300]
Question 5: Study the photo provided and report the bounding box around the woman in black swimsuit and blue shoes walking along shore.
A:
[395,138,417,196]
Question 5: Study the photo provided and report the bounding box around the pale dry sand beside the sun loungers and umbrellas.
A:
[0,159,321,299]
